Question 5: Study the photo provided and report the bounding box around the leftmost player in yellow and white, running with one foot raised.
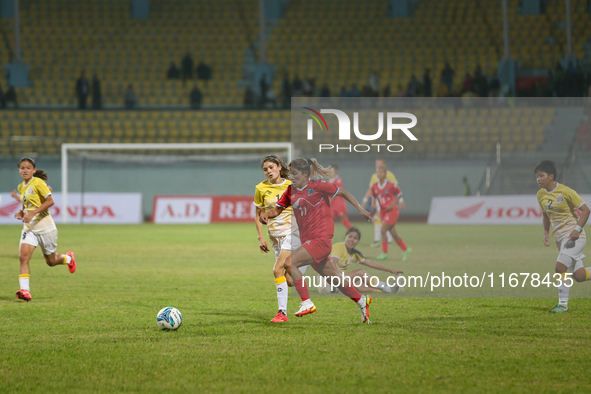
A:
[14,157,76,301]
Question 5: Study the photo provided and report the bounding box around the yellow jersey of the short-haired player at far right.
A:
[537,182,586,242]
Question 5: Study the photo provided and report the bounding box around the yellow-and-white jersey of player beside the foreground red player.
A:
[254,179,299,237]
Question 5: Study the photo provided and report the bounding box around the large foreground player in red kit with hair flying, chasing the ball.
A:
[260,158,372,323]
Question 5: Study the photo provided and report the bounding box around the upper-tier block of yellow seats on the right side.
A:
[268,0,591,95]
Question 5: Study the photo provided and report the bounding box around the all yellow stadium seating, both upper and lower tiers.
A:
[0,0,591,159]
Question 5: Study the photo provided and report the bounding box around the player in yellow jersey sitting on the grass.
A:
[318,227,404,293]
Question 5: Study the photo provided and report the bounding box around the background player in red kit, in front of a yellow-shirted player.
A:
[371,167,412,261]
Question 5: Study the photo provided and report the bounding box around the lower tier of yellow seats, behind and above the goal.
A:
[0,108,554,154]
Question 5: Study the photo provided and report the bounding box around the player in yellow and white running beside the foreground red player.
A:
[254,155,301,323]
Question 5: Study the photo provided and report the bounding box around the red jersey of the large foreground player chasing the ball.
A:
[277,180,339,243]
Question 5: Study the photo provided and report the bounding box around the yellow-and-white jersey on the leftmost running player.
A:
[18,177,56,234]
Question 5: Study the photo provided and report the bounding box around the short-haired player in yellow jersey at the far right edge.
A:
[534,160,591,313]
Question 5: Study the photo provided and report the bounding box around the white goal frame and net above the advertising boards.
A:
[61,142,293,222]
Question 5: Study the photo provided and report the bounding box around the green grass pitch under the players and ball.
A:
[0,223,591,393]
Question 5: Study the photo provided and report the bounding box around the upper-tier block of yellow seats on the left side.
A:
[0,0,258,106]
